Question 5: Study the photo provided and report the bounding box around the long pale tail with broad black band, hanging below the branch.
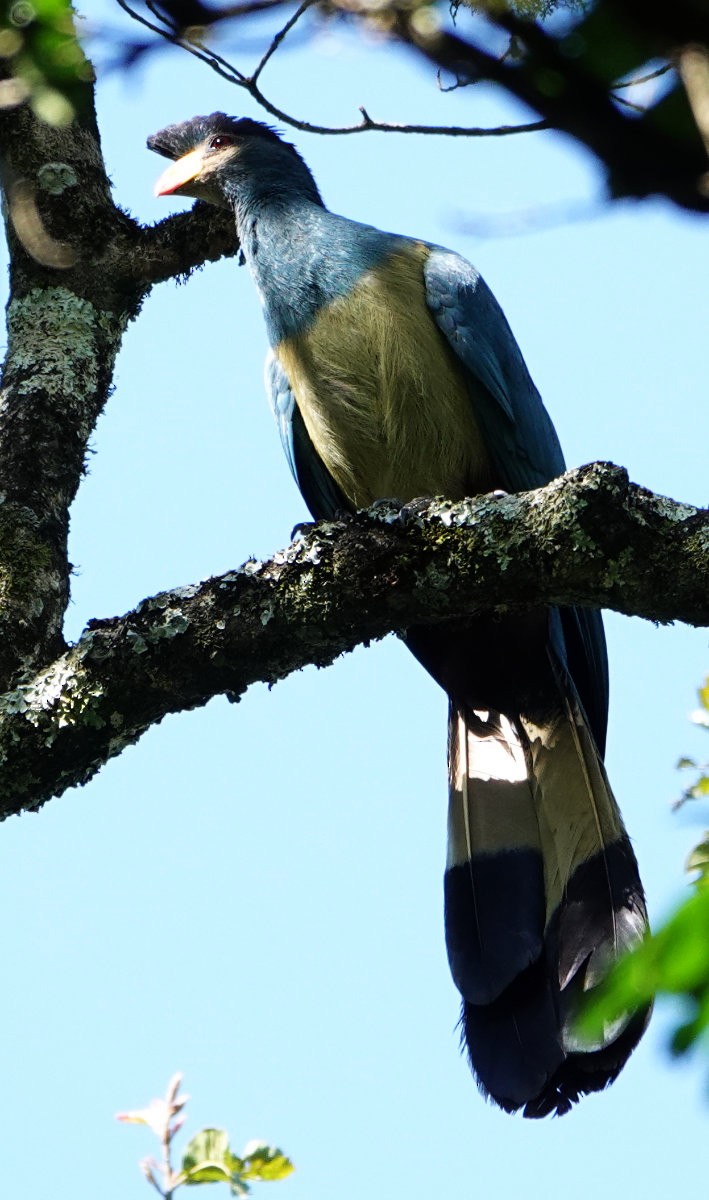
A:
[445,667,648,1117]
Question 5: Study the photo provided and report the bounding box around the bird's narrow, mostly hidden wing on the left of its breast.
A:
[265,352,352,521]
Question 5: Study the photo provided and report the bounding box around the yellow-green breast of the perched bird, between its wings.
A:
[276,242,494,508]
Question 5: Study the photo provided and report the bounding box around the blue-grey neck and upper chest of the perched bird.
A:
[222,143,397,346]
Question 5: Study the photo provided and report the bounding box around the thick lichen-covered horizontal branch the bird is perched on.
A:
[0,463,709,815]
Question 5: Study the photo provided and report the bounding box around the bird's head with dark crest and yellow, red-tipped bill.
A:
[148,113,322,208]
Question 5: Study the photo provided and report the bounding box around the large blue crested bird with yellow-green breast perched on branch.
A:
[148,113,647,1117]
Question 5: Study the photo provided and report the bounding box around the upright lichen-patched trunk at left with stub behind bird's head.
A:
[0,65,236,688]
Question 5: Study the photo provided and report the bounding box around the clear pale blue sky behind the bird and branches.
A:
[0,6,709,1200]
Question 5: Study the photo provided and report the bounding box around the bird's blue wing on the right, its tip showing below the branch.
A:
[425,247,608,754]
